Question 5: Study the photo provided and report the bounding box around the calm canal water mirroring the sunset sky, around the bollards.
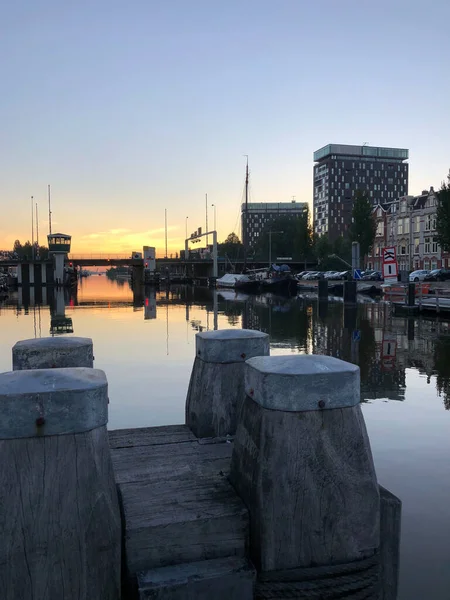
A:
[0,276,450,600]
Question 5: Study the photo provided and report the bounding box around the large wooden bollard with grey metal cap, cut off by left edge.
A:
[0,368,121,600]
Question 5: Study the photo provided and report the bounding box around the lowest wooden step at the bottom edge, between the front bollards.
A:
[138,557,256,600]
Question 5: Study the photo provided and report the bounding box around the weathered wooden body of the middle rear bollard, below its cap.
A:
[186,357,250,438]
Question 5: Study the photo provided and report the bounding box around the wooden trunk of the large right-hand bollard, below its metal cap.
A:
[230,397,380,571]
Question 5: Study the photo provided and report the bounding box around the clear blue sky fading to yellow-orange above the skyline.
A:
[0,0,450,255]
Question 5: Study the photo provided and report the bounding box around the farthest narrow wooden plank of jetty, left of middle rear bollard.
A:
[109,425,197,448]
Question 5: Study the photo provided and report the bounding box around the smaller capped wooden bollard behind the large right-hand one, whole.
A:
[186,329,269,438]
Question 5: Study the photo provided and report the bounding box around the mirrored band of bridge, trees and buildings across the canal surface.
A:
[3,278,450,409]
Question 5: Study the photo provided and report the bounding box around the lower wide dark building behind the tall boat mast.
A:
[241,200,308,248]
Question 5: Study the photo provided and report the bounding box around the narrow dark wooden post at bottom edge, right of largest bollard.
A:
[380,485,402,600]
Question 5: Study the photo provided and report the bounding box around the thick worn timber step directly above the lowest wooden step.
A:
[120,476,248,574]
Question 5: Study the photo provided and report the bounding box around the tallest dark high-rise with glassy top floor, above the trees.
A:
[313,144,409,241]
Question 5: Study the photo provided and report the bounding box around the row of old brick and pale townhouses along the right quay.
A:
[366,188,450,271]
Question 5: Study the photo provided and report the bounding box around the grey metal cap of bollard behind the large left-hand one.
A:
[12,337,94,371]
